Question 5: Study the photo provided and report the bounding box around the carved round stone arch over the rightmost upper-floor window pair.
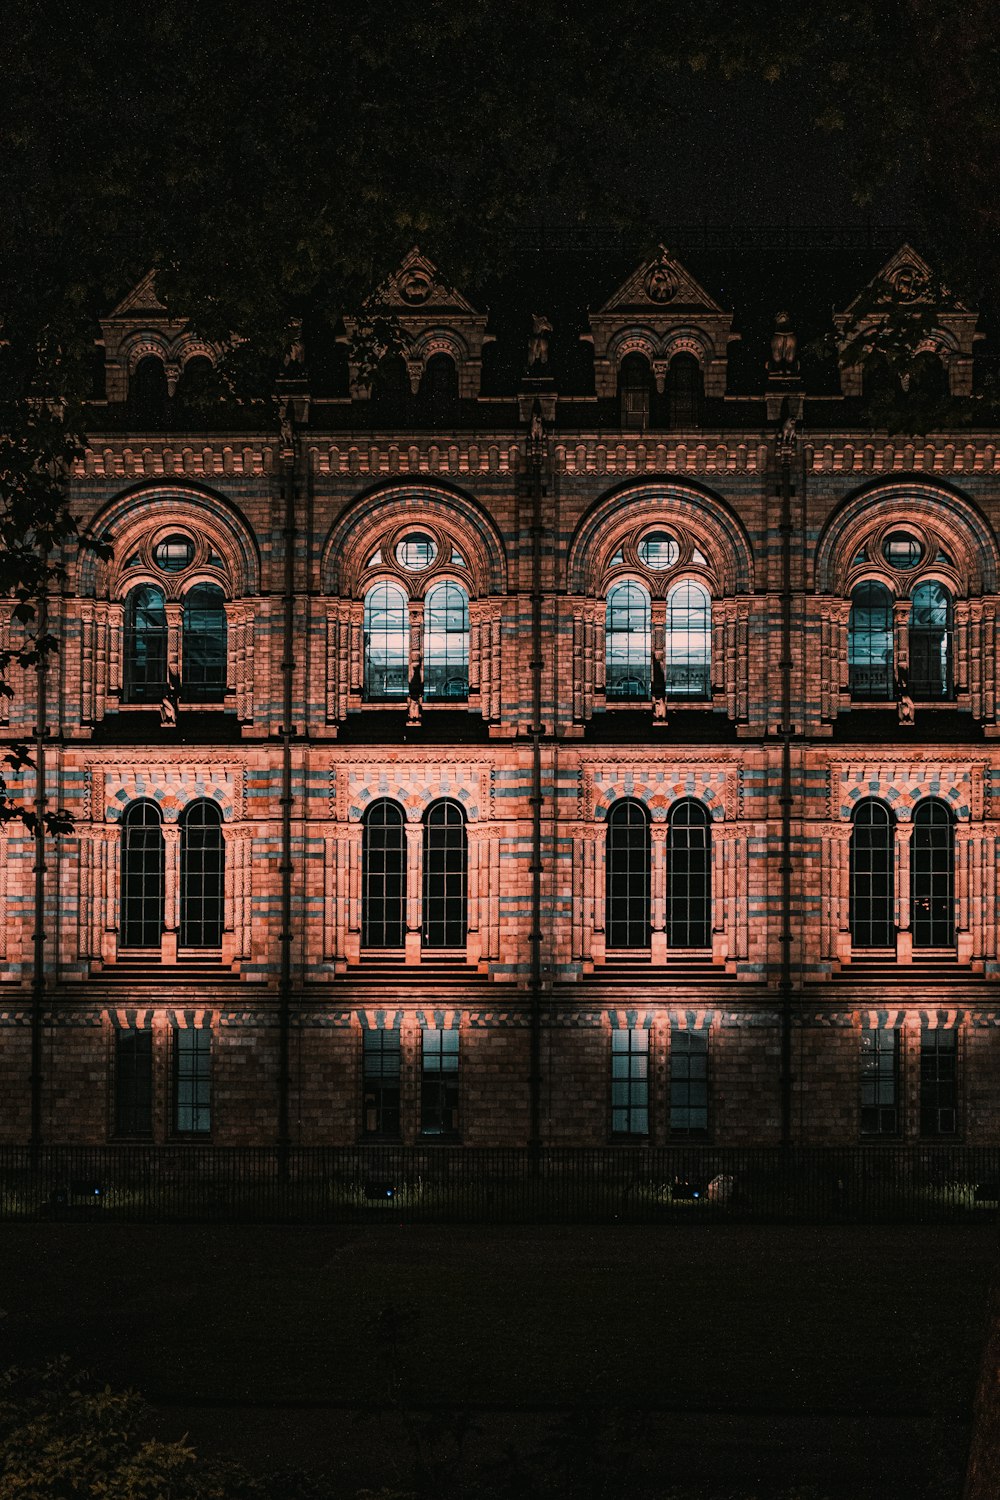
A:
[816,476,1000,596]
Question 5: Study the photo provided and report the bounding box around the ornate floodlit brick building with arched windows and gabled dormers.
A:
[0,245,1000,1146]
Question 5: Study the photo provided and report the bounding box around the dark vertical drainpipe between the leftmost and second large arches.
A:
[277,420,297,1152]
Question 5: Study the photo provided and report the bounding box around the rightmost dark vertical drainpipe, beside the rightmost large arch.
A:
[778,434,793,1146]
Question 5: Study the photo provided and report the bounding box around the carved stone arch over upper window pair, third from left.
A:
[567,480,754,596]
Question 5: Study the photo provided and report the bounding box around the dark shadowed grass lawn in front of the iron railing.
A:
[0,1223,997,1500]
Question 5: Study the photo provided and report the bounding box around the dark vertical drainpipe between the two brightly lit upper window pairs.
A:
[528,414,544,1160]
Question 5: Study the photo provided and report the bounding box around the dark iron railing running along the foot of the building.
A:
[0,1145,1000,1224]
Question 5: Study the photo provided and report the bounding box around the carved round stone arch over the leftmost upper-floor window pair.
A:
[76,483,261,599]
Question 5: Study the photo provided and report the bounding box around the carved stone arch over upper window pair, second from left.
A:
[321,482,507,599]
